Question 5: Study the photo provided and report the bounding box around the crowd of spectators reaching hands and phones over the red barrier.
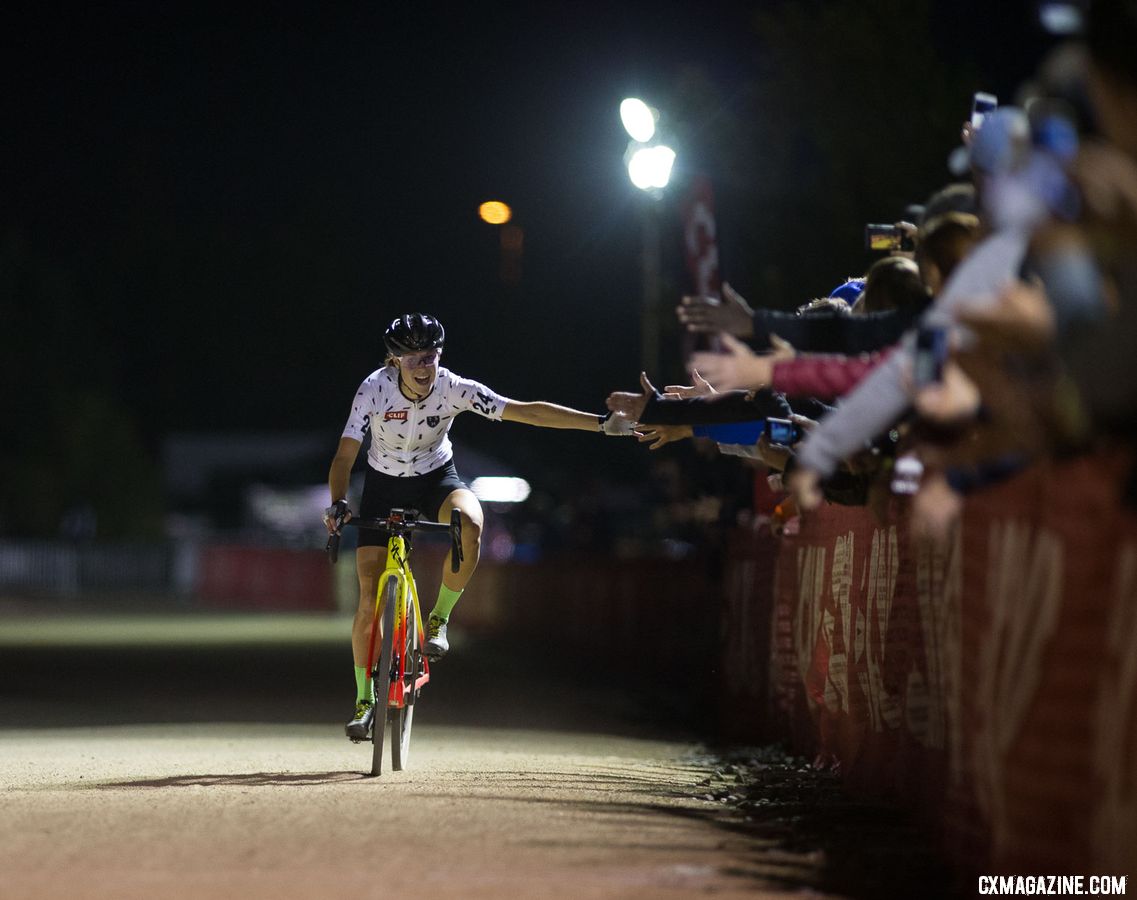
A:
[608,0,1137,540]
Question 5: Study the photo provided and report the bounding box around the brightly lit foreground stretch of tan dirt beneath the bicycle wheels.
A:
[0,724,818,900]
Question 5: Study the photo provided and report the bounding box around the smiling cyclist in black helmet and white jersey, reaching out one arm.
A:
[324,313,632,740]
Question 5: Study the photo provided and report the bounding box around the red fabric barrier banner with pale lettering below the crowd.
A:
[754,456,1137,874]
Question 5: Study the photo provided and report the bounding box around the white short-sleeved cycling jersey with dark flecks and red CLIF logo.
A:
[343,366,509,476]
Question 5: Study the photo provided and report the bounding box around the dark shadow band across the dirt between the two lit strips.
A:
[0,638,712,739]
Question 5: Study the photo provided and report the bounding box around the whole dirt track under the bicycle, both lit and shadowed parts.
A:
[0,611,845,900]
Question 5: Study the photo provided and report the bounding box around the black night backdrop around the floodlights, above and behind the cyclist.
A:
[0,0,1051,535]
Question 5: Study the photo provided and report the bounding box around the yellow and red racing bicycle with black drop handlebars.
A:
[326,509,463,776]
